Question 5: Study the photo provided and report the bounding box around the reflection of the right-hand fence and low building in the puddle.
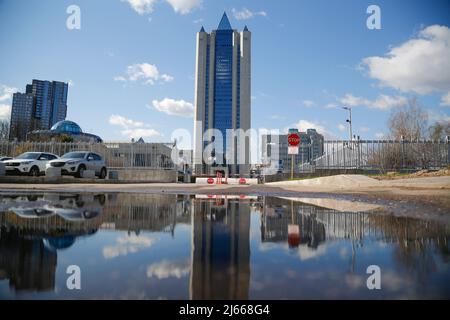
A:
[261,204,450,243]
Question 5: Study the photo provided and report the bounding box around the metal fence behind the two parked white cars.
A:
[0,141,175,169]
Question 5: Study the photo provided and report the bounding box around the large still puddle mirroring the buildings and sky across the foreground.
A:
[0,192,450,299]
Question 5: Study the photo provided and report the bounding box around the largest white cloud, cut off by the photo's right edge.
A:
[362,25,450,103]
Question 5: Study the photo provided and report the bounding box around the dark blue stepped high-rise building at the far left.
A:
[9,79,68,140]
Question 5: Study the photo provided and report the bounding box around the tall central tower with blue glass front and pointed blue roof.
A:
[193,13,251,174]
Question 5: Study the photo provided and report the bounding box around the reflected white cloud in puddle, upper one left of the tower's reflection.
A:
[103,235,157,259]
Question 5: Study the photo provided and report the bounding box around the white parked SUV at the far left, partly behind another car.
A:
[3,152,58,177]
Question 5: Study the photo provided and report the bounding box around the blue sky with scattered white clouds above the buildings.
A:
[0,0,450,141]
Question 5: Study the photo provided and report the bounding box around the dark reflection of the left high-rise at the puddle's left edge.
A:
[0,228,57,291]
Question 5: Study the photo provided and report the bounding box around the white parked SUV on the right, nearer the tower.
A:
[47,151,107,179]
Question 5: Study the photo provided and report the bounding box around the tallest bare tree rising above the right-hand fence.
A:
[388,98,428,141]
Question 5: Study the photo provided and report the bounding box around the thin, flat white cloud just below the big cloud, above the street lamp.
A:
[339,93,408,110]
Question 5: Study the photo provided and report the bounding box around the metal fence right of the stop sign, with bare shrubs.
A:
[311,139,450,171]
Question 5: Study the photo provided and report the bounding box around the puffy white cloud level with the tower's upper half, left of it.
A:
[114,63,174,85]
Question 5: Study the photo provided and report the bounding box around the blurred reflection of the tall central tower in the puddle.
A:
[190,198,250,299]
